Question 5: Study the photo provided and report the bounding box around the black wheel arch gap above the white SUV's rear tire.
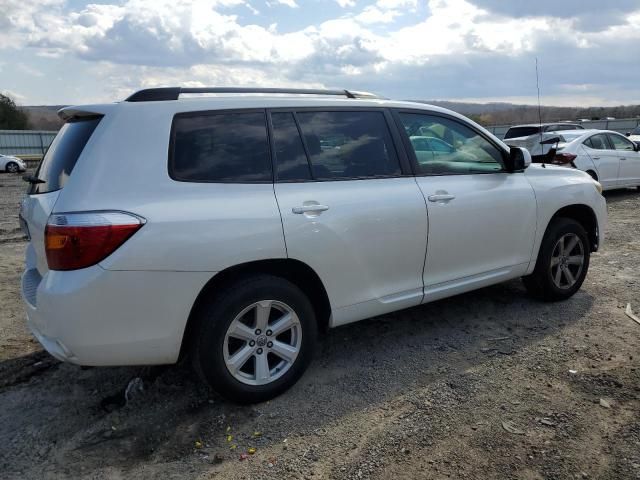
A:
[180,258,331,358]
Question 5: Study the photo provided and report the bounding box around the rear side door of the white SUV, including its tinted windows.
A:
[271,109,427,326]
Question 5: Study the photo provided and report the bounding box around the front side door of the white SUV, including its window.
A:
[397,112,536,300]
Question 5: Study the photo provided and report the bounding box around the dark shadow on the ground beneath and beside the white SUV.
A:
[0,281,594,478]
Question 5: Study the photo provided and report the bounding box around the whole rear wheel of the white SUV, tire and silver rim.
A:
[191,275,317,403]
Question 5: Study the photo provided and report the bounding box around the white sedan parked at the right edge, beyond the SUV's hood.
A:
[524,130,640,190]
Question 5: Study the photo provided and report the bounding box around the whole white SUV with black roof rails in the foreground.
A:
[21,88,606,402]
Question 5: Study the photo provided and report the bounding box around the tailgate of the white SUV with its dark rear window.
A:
[20,116,102,275]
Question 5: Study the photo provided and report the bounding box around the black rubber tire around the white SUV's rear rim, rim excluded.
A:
[190,275,318,403]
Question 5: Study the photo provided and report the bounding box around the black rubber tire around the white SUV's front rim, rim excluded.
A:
[522,218,591,302]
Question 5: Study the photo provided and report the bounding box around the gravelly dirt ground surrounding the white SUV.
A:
[0,174,640,479]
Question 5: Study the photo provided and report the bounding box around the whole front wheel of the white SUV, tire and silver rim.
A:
[522,218,591,301]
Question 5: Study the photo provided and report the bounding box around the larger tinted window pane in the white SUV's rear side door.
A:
[297,112,400,179]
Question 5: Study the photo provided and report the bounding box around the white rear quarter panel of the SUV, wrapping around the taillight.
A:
[55,102,286,272]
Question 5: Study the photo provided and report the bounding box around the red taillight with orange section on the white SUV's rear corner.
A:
[44,212,144,270]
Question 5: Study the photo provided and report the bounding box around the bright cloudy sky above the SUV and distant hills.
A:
[0,0,640,106]
